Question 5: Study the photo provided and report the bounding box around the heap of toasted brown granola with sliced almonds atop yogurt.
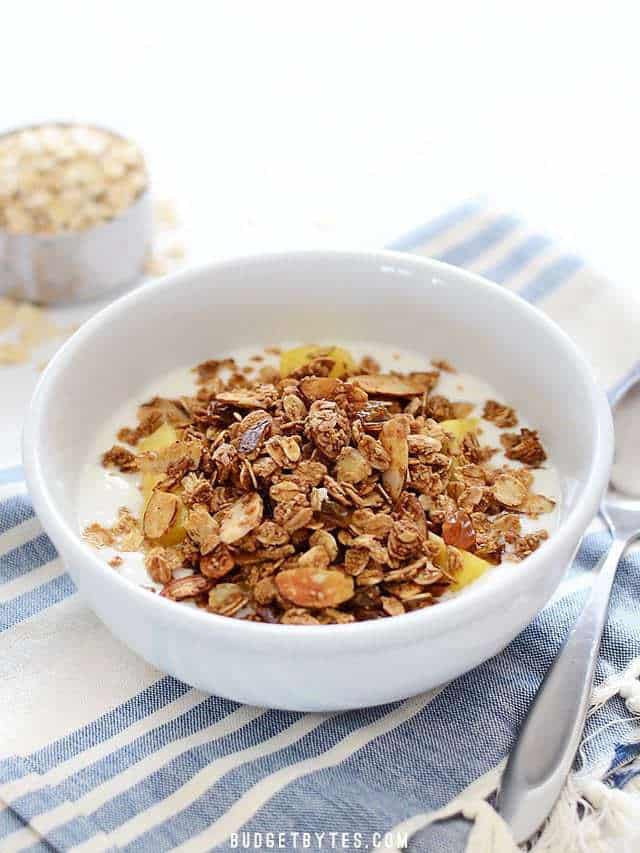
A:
[85,346,555,625]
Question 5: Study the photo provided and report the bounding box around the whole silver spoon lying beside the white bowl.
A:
[497,363,640,844]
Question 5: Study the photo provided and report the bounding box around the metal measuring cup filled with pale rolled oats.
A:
[0,124,151,303]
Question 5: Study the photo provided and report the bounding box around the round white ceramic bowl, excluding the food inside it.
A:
[24,252,613,710]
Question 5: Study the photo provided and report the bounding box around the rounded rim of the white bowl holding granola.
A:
[23,249,613,651]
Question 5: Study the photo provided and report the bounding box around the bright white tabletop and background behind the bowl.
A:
[0,0,640,467]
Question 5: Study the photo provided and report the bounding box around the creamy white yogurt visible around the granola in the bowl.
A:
[77,342,561,588]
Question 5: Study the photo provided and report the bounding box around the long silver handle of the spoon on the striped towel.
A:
[498,538,627,844]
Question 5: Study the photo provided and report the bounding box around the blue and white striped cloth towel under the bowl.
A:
[0,203,640,853]
